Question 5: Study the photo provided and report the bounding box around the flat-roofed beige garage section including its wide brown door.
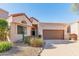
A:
[40,23,68,40]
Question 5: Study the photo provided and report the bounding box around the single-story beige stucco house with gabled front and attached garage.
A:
[7,13,68,42]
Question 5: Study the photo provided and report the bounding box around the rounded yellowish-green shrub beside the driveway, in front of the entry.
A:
[30,38,44,47]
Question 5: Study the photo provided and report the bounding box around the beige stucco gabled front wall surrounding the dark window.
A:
[7,16,32,42]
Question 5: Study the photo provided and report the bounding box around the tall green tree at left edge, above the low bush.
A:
[0,19,8,41]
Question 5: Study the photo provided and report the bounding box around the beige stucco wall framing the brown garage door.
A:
[39,23,69,39]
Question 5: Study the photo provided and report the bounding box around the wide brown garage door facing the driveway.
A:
[43,30,64,39]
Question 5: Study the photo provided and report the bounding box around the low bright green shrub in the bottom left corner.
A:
[0,41,12,52]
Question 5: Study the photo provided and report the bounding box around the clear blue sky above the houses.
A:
[0,3,79,23]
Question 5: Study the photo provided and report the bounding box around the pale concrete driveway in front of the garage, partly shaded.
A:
[41,40,79,56]
